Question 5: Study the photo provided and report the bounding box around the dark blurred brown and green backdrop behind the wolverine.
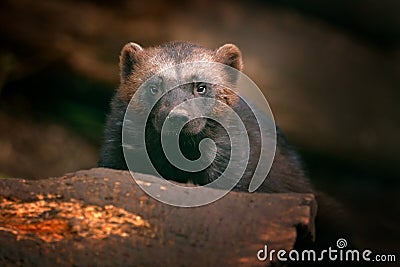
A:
[0,0,400,260]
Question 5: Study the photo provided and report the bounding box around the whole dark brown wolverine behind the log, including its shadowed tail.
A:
[99,42,351,262]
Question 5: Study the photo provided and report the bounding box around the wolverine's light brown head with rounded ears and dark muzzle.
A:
[118,42,242,135]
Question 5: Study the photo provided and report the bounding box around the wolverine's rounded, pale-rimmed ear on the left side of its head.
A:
[119,43,143,80]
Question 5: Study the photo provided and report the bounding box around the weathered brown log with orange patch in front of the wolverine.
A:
[0,168,316,266]
